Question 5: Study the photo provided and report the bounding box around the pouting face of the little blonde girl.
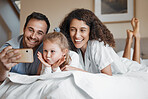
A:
[43,40,65,65]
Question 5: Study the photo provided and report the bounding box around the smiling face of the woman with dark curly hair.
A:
[69,19,90,50]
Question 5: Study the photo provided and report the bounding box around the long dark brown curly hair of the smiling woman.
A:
[59,8,115,50]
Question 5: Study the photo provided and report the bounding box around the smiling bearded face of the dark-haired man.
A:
[23,19,47,49]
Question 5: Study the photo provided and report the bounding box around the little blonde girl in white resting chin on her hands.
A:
[37,32,80,74]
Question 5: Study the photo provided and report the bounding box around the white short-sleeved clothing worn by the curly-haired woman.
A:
[78,40,146,74]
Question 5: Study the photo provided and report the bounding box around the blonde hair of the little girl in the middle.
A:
[43,32,71,68]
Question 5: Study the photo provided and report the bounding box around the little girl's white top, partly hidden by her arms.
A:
[40,51,82,74]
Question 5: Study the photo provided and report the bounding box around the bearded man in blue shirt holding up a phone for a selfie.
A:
[0,12,50,82]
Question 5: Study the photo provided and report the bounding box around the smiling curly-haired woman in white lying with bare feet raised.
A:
[59,9,146,75]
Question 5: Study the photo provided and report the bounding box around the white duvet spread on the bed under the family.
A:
[0,71,148,99]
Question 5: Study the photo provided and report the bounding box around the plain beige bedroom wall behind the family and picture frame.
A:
[20,0,148,38]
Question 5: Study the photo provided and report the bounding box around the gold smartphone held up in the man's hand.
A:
[7,48,34,63]
